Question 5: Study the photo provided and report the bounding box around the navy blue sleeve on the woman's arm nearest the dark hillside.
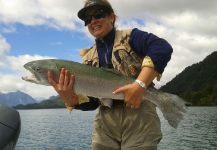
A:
[129,28,173,74]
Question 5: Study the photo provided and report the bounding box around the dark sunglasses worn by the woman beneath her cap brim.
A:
[83,9,109,26]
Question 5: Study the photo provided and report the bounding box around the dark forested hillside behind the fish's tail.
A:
[160,51,217,106]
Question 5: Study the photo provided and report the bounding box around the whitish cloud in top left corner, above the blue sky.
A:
[0,0,82,30]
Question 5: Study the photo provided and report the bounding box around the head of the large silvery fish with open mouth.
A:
[22,59,59,85]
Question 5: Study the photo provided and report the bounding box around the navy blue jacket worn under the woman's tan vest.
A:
[75,28,173,111]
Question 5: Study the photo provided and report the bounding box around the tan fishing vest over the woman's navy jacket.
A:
[80,29,143,78]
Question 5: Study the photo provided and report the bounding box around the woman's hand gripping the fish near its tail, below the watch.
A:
[113,82,145,108]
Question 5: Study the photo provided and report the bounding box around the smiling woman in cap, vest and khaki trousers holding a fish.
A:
[48,0,173,150]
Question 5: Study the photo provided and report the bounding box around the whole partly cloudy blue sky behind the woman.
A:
[0,0,217,99]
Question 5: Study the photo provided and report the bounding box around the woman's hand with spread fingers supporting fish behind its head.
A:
[48,68,78,107]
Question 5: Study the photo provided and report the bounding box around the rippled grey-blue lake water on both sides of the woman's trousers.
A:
[15,107,217,150]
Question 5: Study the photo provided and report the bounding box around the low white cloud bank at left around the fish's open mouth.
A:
[0,37,56,98]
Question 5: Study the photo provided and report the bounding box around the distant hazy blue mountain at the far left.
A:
[0,91,37,107]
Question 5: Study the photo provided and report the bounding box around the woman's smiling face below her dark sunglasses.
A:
[87,9,115,38]
